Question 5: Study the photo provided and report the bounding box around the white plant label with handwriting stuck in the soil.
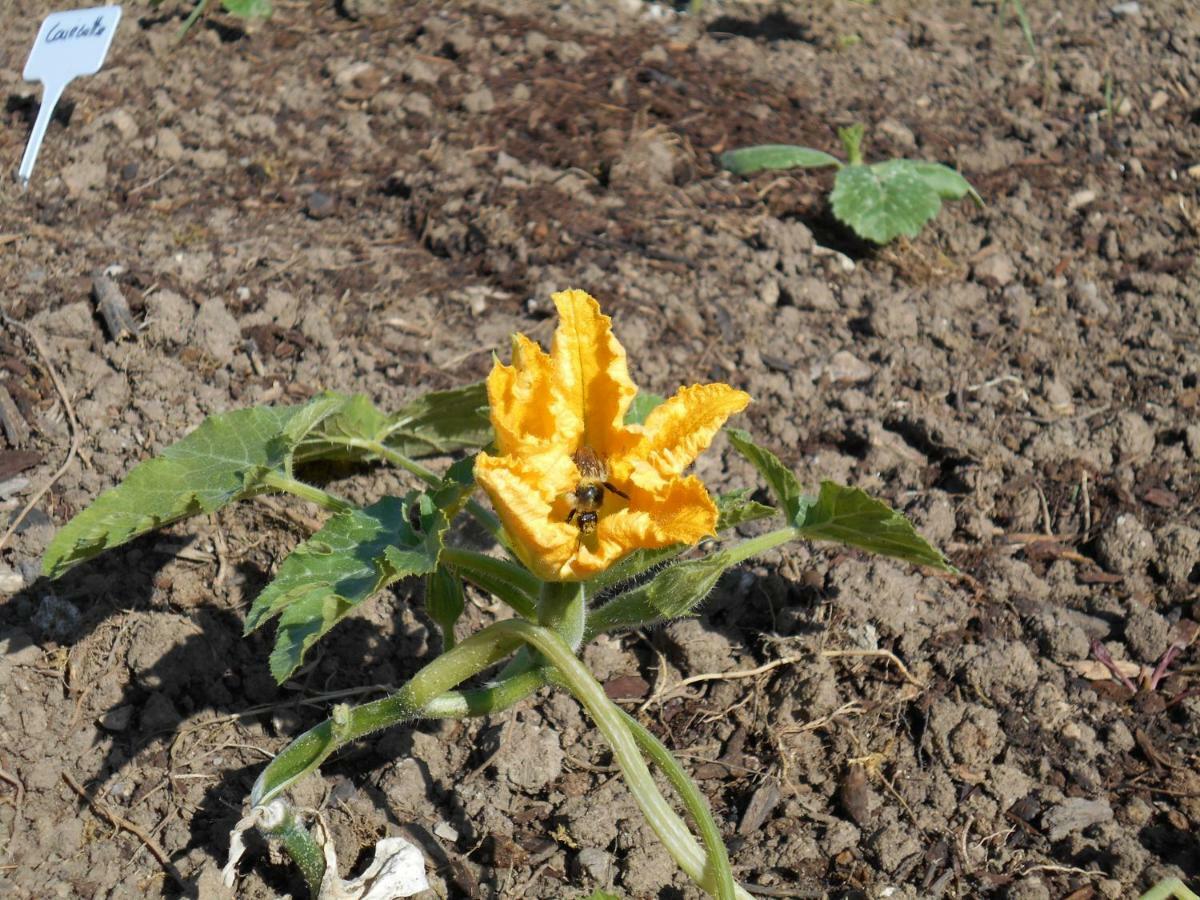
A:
[17,6,121,185]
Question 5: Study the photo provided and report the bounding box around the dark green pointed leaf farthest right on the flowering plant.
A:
[796,481,955,572]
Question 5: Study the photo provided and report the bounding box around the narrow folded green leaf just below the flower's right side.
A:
[583,550,738,643]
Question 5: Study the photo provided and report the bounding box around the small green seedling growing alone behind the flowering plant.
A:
[721,125,983,244]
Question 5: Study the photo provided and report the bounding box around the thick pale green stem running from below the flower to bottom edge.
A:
[508,619,750,900]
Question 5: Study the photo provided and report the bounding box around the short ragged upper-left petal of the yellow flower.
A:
[487,335,583,455]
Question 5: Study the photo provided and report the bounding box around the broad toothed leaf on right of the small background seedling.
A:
[830,160,978,244]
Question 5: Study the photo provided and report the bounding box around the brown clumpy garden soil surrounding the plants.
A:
[0,0,1200,900]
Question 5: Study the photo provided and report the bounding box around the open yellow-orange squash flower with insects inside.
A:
[475,290,750,581]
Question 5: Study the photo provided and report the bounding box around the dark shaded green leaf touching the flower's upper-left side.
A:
[385,382,492,456]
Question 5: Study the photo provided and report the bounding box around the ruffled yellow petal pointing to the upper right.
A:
[629,383,750,479]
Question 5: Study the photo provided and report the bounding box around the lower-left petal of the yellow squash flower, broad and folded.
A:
[475,451,580,581]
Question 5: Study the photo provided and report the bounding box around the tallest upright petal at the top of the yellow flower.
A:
[551,290,637,456]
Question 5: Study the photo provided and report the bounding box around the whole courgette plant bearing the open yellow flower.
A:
[42,290,953,900]
